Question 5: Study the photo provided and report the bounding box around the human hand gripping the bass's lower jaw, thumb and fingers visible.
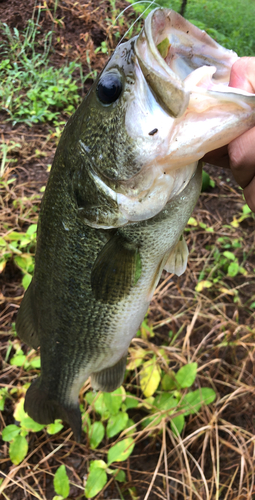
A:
[203,57,255,212]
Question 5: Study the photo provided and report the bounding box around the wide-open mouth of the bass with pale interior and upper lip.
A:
[135,8,237,118]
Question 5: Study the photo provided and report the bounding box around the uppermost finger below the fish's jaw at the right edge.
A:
[228,127,255,188]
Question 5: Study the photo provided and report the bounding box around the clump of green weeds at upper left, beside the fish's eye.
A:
[0,19,81,125]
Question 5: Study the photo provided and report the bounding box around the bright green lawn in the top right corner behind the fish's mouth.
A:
[130,0,255,57]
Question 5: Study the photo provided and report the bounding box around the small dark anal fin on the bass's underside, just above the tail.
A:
[90,356,127,392]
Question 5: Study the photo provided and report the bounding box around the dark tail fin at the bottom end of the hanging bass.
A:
[24,377,81,442]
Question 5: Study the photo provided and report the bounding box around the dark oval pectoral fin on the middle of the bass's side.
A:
[91,231,141,304]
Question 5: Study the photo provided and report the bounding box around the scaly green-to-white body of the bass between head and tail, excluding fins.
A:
[34,158,202,403]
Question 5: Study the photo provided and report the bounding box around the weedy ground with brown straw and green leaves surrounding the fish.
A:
[0,0,255,500]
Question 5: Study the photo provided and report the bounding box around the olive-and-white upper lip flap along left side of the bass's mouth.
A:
[134,8,190,118]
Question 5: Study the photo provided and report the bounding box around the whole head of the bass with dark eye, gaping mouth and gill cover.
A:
[63,8,255,229]
